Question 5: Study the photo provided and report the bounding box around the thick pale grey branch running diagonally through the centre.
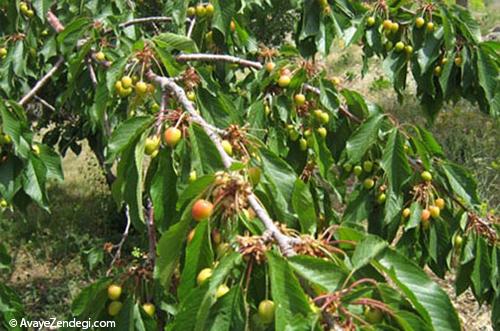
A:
[146,71,298,256]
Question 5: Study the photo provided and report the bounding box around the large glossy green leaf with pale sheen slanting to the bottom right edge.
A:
[375,249,460,331]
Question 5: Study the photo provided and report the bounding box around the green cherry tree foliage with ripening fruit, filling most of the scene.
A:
[0,0,500,330]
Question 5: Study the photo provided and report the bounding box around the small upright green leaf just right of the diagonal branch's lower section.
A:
[292,179,317,234]
